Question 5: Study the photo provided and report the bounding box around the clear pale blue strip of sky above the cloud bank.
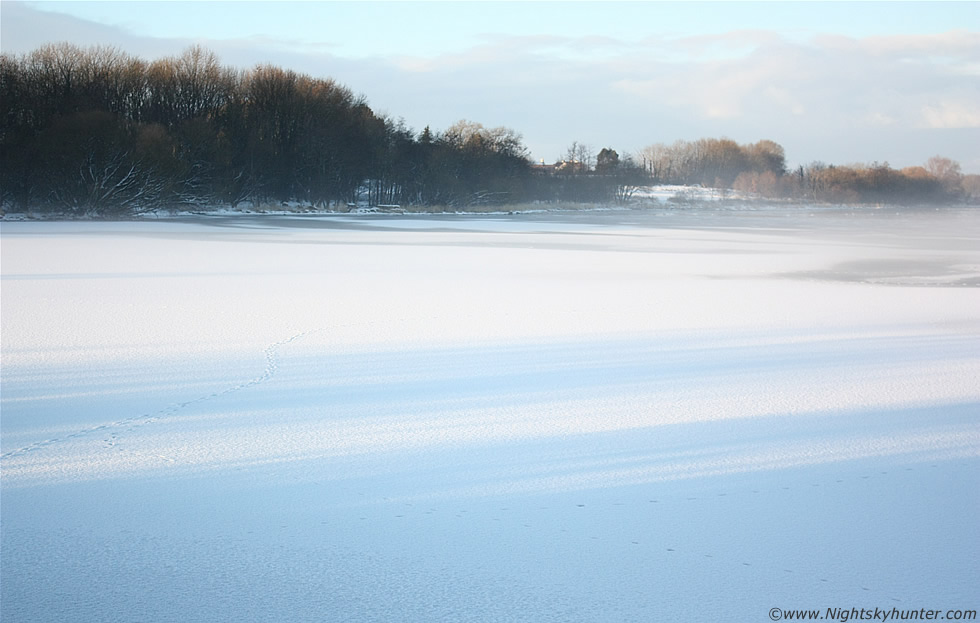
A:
[11,0,980,58]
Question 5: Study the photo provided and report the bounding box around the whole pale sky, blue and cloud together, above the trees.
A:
[0,0,980,173]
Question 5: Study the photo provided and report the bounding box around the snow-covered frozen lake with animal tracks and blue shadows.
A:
[0,209,980,623]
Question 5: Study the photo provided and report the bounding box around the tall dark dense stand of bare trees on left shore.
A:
[0,44,532,215]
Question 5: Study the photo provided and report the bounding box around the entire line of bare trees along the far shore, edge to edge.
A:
[0,43,980,215]
